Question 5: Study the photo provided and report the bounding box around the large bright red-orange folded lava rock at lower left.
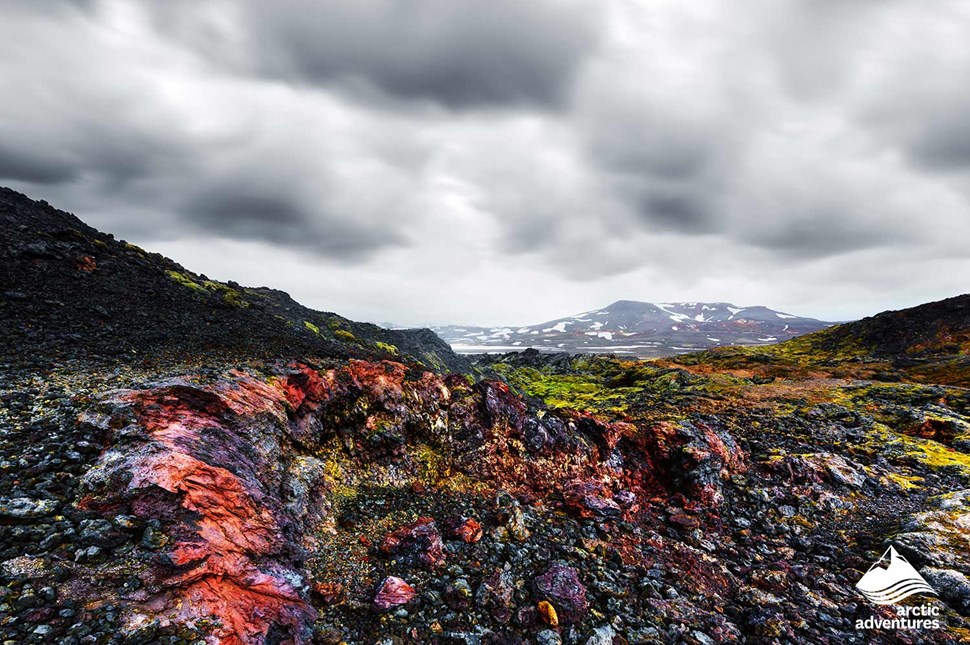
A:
[85,377,316,645]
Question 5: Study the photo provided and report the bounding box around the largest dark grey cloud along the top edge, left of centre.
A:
[156,0,602,108]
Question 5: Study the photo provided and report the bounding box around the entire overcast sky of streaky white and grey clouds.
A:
[0,0,970,324]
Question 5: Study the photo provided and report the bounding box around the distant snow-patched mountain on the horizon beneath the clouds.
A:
[432,300,832,356]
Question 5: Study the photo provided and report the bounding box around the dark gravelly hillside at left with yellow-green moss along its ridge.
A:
[0,188,466,371]
